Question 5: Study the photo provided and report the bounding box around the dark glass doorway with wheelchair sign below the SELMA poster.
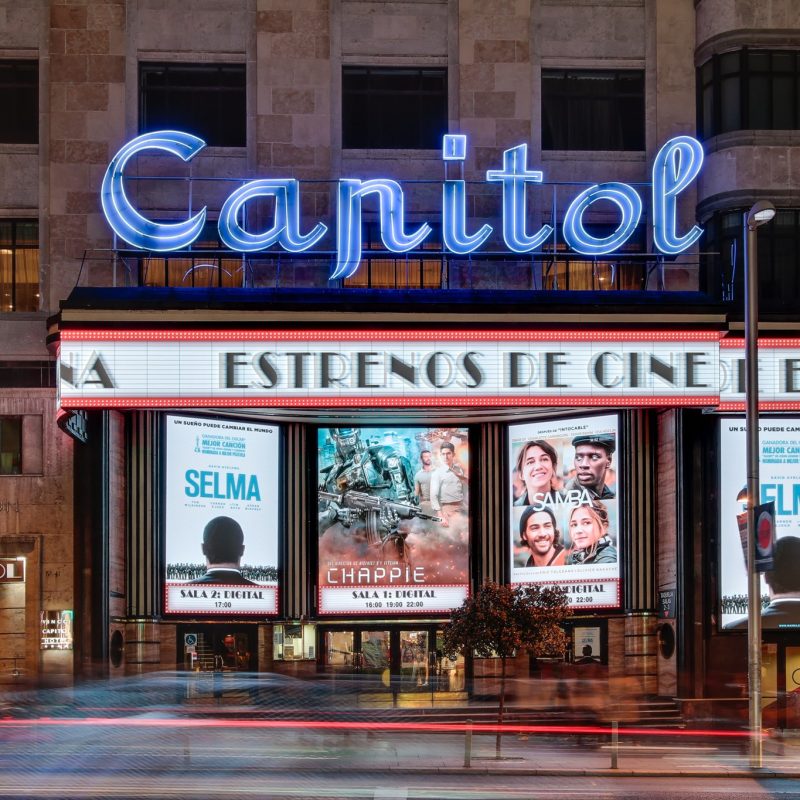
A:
[176,623,258,672]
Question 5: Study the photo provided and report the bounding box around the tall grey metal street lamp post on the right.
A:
[744,200,775,767]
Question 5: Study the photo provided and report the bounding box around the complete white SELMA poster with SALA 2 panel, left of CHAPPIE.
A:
[164,416,280,615]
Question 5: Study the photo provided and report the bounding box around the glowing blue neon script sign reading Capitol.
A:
[101,131,703,280]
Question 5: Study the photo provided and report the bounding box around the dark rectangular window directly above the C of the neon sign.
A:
[139,64,247,147]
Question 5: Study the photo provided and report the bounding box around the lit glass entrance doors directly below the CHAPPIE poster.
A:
[318,625,464,692]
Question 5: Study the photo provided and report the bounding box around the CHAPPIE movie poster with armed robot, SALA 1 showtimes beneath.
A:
[317,427,470,616]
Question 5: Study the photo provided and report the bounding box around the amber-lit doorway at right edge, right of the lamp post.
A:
[761,635,800,729]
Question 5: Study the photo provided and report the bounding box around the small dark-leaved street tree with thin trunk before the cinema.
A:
[443,582,570,758]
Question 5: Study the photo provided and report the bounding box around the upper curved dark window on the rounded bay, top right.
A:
[697,48,800,138]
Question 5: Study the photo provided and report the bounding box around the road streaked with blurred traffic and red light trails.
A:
[0,713,800,800]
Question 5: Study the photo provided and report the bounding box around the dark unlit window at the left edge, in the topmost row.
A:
[0,60,39,144]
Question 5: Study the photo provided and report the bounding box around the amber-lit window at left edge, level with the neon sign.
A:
[0,219,39,311]
